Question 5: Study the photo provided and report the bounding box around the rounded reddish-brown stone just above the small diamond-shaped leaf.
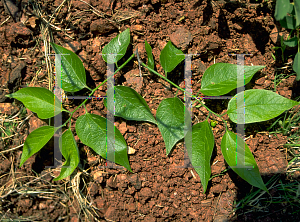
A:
[170,27,193,50]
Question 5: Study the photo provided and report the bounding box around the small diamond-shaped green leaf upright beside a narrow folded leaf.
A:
[159,41,185,72]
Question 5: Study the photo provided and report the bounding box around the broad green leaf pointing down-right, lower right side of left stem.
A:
[75,113,132,172]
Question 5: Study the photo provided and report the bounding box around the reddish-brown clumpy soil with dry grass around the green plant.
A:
[0,0,300,222]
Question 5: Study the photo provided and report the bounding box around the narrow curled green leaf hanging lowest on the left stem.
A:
[53,129,80,181]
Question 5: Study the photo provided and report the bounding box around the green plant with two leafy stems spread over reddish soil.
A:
[5,29,299,192]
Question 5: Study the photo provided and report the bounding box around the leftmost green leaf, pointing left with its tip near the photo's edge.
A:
[7,87,66,119]
